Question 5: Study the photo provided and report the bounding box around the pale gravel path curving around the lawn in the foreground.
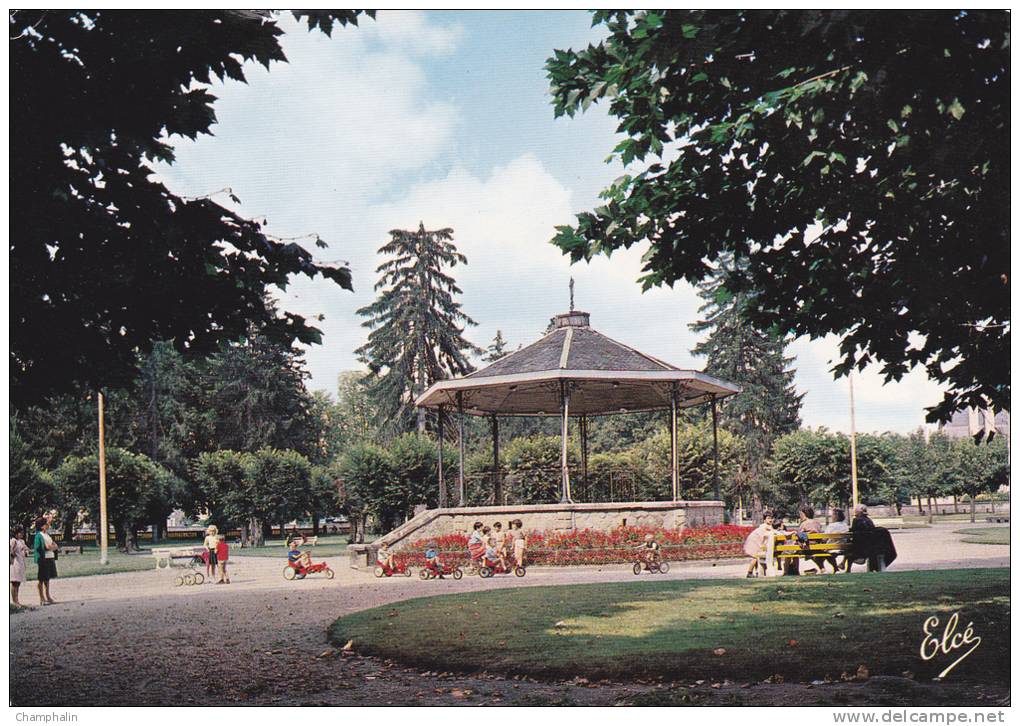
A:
[10,524,1009,706]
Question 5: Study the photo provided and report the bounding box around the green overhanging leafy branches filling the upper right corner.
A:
[547,10,1010,420]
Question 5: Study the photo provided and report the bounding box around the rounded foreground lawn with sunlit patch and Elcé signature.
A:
[329,569,1010,682]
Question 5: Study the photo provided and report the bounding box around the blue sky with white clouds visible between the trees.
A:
[159,11,940,431]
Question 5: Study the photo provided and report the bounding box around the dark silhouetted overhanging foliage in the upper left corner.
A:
[9,10,371,403]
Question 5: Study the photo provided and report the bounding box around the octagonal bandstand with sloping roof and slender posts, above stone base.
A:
[415,310,741,509]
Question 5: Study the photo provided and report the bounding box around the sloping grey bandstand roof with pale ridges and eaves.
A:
[415,311,741,416]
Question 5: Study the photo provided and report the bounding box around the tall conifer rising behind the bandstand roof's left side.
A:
[356,222,481,431]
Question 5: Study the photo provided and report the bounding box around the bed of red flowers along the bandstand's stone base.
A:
[395,524,751,567]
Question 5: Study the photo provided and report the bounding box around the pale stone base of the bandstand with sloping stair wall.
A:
[348,501,723,569]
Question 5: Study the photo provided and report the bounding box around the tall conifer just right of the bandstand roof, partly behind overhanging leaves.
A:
[691,258,803,521]
